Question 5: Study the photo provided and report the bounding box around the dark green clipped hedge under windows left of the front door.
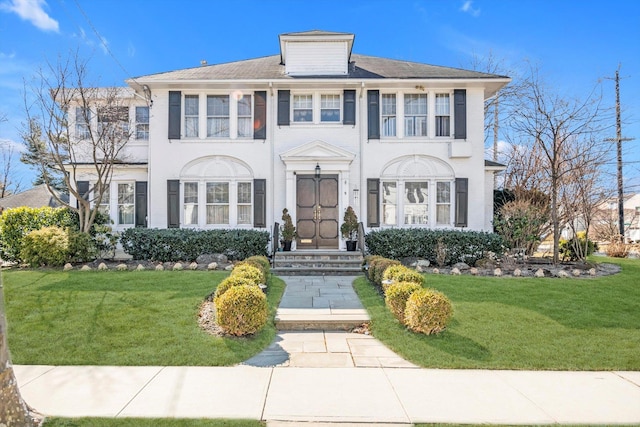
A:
[120,228,269,262]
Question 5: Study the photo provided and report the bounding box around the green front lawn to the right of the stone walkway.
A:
[354,259,640,370]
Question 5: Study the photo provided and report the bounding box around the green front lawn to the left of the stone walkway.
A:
[2,270,284,366]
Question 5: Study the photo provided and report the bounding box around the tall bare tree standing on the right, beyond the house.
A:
[510,68,609,263]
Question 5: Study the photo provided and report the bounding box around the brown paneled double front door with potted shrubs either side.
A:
[296,175,339,249]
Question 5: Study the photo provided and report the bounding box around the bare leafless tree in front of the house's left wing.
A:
[23,53,131,232]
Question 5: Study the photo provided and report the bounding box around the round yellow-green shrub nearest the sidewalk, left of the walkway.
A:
[215,285,268,336]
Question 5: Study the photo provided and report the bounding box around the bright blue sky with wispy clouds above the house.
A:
[0,0,640,191]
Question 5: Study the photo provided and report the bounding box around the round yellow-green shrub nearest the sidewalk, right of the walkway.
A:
[404,288,453,335]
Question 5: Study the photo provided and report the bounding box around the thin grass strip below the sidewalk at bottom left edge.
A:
[43,417,266,427]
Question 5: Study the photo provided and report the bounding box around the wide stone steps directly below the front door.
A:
[272,250,363,276]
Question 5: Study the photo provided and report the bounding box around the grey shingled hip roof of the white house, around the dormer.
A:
[134,54,509,83]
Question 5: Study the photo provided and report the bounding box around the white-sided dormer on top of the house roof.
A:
[279,30,355,76]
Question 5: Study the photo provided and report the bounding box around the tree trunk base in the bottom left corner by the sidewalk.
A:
[0,275,42,427]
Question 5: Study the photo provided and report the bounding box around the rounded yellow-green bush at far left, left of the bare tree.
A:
[20,226,69,267]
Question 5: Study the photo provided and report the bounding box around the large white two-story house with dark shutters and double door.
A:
[71,31,510,249]
